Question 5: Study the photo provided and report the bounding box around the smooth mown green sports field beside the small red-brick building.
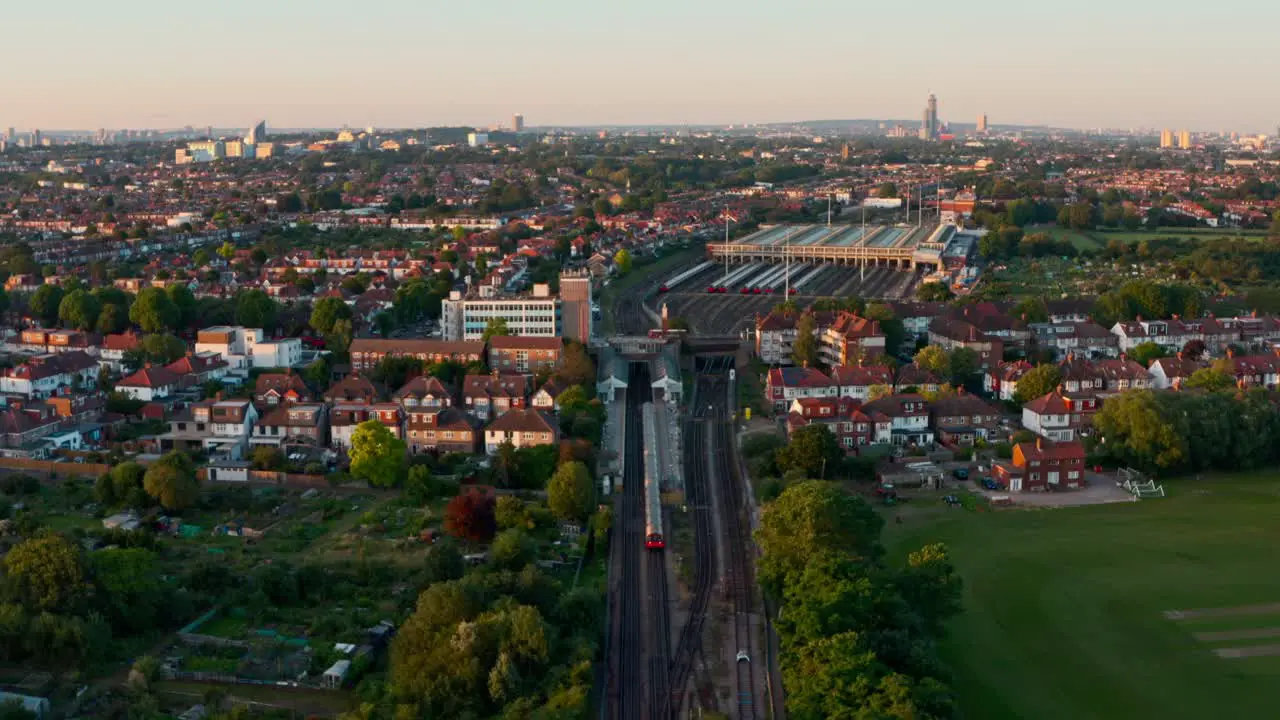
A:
[888,475,1280,720]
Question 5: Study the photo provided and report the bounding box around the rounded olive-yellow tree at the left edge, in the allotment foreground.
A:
[4,534,90,612]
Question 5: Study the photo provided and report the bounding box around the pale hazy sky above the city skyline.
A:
[10,0,1280,133]
